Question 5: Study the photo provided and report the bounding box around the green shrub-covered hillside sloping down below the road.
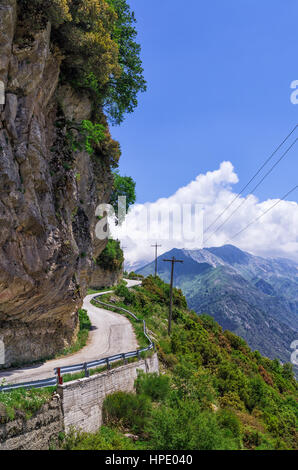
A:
[64,276,298,450]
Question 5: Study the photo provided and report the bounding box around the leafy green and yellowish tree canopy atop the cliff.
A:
[19,0,146,124]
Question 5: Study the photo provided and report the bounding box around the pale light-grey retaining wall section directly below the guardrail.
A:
[58,354,159,432]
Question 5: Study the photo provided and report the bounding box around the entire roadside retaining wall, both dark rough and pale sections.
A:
[0,354,159,450]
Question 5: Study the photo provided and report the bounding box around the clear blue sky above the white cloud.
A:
[112,0,298,203]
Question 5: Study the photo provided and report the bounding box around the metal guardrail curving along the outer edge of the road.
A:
[0,288,155,392]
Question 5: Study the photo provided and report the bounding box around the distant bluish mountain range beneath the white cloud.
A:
[137,245,298,370]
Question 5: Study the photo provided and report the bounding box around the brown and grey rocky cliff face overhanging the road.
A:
[0,0,112,366]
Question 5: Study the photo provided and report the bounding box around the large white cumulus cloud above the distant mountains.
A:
[113,161,298,268]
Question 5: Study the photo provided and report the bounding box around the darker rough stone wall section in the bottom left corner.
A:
[0,395,63,450]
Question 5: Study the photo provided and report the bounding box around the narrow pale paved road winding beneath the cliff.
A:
[0,280,140,383]
